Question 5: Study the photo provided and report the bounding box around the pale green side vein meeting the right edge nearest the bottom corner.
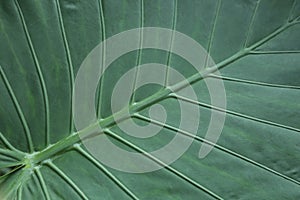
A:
[134,114,300,185]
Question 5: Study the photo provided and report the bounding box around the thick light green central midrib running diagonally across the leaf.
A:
[32,19,299,164]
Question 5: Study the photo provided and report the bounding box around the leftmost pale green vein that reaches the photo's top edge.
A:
[15,0,50,147]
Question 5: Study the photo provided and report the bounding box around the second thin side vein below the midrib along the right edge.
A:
[208,74,300,89]
